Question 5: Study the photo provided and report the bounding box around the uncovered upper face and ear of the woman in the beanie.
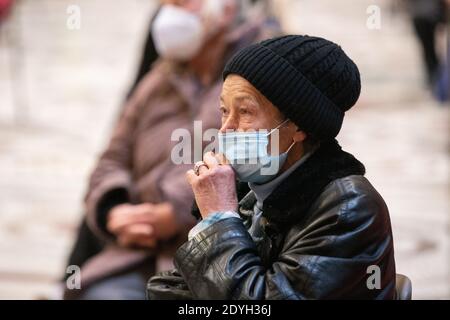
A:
[220,74,297,155]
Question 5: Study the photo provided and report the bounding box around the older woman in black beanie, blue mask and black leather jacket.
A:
[148,35,395,299]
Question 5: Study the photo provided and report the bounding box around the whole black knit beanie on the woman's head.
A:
[223,35,361,140]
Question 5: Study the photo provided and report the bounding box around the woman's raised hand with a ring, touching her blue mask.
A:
[186,152,238,218]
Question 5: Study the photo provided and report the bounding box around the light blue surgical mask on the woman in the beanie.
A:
[219,119,295,184]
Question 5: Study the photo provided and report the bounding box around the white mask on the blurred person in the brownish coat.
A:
[152,4,204,62]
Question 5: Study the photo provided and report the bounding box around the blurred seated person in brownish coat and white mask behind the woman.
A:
[64,0,279,299]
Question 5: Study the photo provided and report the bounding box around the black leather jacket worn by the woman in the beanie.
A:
[148,141,395,300]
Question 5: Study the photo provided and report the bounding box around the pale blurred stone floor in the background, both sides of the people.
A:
[0,0,450,299]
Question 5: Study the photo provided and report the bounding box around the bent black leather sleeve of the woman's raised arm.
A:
[171,180,395,300]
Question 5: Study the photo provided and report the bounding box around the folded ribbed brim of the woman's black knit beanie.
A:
[223,35,359,140]
